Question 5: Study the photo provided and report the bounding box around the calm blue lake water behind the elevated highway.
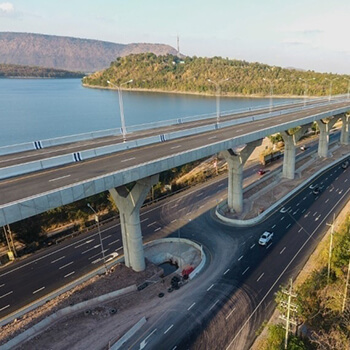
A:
[0,79,298,146]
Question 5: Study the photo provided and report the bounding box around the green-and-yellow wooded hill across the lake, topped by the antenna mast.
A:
[83,54,350,96]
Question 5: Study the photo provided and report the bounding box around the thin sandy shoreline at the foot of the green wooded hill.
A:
[82,83,304,99]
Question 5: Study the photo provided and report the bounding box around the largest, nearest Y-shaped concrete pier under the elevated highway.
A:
[109,174,159,272]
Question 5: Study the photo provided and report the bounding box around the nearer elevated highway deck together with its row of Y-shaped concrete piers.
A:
[0,98,350,271]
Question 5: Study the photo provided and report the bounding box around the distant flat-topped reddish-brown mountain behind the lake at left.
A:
[0,32,176,73]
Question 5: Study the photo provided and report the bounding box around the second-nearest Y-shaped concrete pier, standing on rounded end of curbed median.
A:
[221,139,262,213]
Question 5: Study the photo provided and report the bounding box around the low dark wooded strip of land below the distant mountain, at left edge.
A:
[0,63,84,78]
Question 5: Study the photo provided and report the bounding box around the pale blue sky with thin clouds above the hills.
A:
[0,0,350,74]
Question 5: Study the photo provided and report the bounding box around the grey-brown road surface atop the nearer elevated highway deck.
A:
[0,98,349,207]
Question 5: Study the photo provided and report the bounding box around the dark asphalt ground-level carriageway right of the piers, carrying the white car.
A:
[121,159,350,350]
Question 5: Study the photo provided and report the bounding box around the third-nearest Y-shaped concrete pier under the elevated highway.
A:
[281,124,311,180]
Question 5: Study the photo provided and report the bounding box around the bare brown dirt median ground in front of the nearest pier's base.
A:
[0,262,191,350]
